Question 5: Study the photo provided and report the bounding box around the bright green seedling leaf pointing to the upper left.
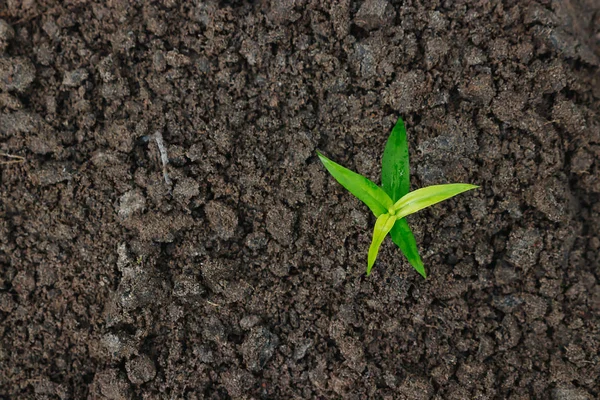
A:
[317,151,394,217]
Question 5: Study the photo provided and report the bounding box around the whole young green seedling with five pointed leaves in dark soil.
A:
[317,118,478,278]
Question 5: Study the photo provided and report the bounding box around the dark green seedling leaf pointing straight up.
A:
[381,118,410,201]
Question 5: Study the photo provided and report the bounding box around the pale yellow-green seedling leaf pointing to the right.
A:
[390,183,479,219]
